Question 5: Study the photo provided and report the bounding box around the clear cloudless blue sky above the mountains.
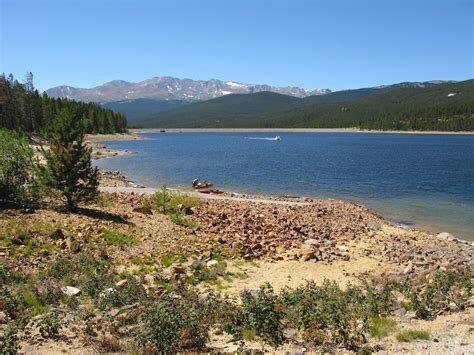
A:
[0,0,474,90]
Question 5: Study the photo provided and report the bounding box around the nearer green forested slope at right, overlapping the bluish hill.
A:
[248,80,474,131]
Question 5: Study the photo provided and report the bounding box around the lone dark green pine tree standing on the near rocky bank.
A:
[39,108,98,209]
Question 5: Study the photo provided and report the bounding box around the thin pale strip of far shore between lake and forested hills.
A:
[129,128,474,135]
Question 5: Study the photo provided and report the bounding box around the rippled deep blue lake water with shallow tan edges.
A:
[96,132,474,240]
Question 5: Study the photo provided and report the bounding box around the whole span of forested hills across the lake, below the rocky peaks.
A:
[134,80,474,131]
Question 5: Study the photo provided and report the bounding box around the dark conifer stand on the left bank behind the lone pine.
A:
[0,73,127,133]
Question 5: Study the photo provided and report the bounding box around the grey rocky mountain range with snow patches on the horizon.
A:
[46,76,331,102]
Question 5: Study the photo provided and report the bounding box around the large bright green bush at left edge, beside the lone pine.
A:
[0,129,38,204]
